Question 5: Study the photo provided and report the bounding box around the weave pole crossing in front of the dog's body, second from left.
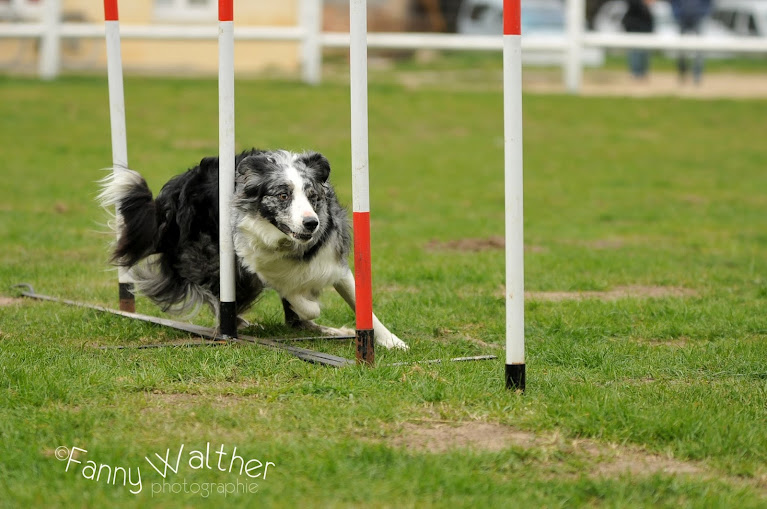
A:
[218,0,237,338]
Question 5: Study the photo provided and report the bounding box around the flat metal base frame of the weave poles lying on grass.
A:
[13,283,497,367]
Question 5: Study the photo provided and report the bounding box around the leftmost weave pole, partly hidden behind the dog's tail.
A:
[104,0,136,313]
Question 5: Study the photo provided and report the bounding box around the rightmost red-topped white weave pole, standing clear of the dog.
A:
[503,0,525,391]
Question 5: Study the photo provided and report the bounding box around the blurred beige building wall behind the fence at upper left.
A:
[0,0,432,76]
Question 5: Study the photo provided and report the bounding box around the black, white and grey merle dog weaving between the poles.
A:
[98,149,408,349]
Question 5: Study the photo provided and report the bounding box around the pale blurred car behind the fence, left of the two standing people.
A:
[456,0,605,66]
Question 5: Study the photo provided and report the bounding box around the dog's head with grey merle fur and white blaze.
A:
[234,150,330,245]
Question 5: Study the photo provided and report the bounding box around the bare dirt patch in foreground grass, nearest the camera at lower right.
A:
[393,421,707,477]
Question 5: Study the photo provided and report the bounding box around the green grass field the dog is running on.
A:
[0,68,767,508]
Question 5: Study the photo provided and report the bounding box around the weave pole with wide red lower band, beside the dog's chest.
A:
[349,0,375,366]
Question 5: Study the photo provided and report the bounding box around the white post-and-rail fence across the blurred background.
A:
[0,0,767,93]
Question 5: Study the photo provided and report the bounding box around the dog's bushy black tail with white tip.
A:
[98,168,158,267]
